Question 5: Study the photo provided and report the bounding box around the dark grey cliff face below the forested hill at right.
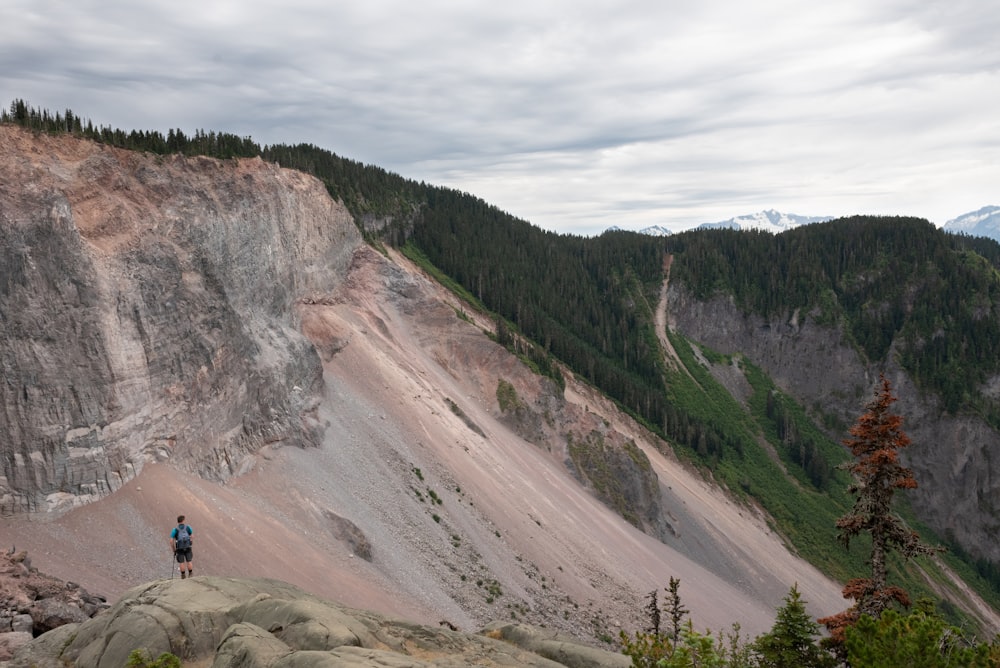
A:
[667,285,1000,561]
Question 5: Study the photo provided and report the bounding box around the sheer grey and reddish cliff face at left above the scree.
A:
[0,126,361,515]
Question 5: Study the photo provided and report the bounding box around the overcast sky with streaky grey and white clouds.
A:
[0,0,1000,234]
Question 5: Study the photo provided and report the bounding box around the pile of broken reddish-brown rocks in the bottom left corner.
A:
[0,551,108,661]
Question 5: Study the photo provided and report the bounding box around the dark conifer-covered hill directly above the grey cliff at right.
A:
[669,222,1000,414]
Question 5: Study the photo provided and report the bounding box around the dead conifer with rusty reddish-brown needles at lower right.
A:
[819,375,941,643]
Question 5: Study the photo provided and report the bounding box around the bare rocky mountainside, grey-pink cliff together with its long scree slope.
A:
[0,127,843,641]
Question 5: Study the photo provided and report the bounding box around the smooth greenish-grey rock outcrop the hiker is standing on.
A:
[8,577,631,668]
